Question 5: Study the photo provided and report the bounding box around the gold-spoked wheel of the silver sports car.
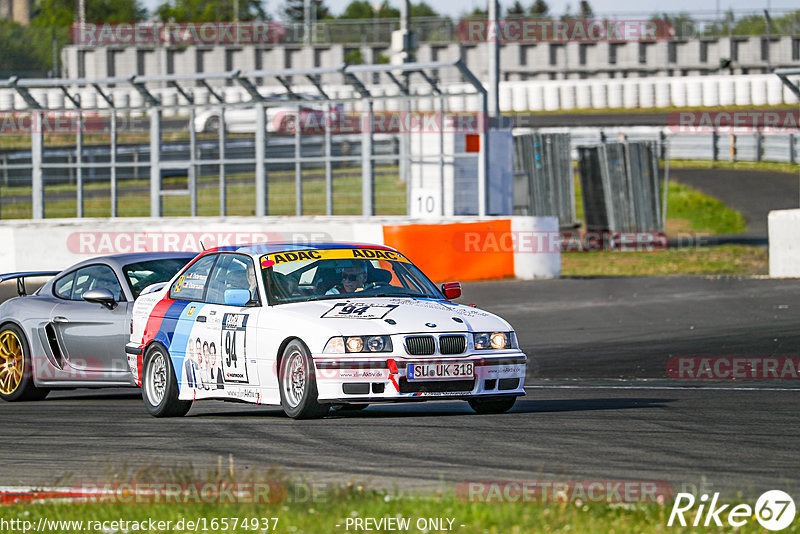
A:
[0,324,50,402]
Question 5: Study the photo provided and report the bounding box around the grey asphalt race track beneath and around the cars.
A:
[0,277,800,494]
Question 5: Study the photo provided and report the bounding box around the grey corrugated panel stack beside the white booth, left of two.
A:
[514,130,576,228]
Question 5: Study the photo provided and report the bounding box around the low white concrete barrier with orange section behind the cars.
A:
[0,217,561,282]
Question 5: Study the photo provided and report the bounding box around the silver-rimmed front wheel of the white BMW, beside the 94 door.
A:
[278,339,331,419]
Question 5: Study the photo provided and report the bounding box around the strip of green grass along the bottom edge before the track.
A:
[2,489,798,534]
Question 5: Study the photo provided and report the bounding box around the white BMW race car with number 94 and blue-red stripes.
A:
[126,243,527,419]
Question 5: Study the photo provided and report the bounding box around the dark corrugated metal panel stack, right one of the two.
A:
[578,142,664,232]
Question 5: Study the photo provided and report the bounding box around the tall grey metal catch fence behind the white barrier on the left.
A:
[0,61,488,218]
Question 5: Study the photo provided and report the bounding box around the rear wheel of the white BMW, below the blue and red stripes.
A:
[142,343,192,417]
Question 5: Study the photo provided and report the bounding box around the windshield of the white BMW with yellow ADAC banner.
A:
[261,248,442,304]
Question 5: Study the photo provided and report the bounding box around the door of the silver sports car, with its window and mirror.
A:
[50,264,133,381]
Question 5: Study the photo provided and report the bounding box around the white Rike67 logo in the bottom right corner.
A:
[667,490,796,531]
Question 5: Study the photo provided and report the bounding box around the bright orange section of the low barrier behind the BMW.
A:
[383,219,514,282]
